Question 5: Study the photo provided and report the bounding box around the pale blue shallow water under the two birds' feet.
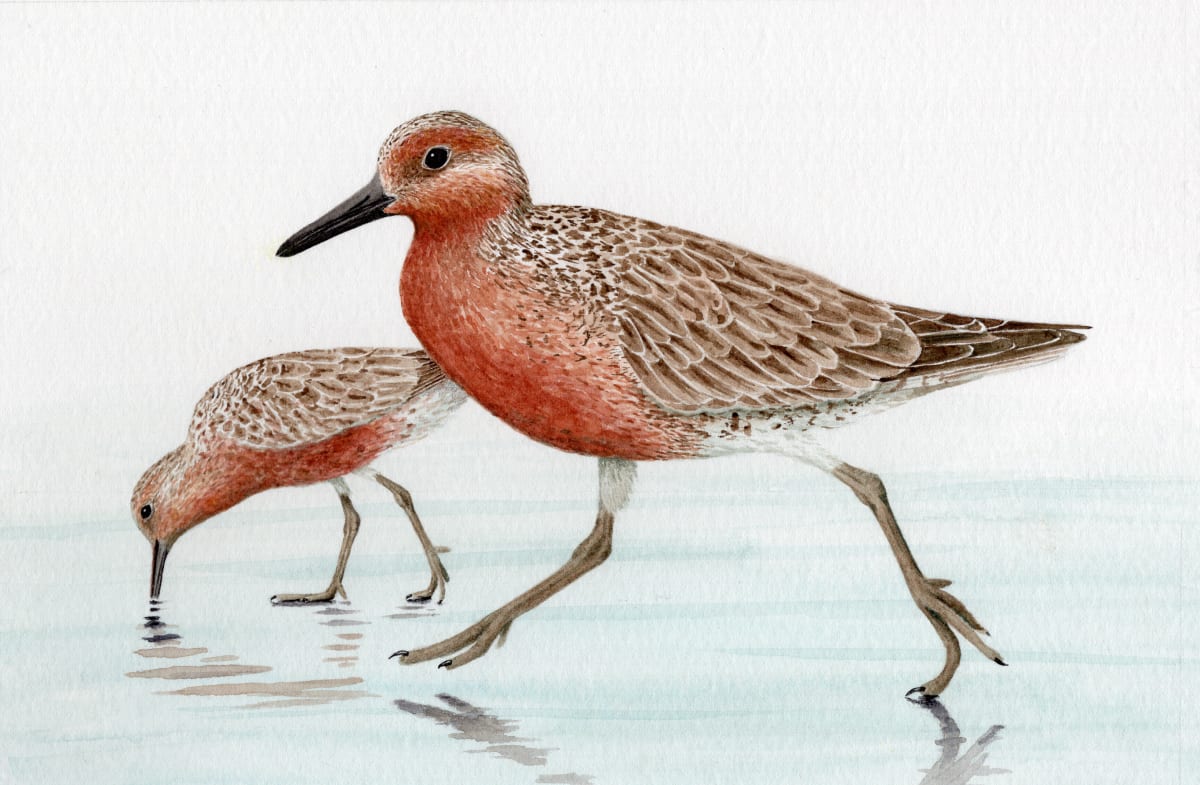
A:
[0,470,1200,785]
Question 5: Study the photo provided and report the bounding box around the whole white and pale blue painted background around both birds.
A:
[0,2,1200,783]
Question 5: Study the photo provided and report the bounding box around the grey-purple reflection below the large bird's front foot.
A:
[396,693,593,785]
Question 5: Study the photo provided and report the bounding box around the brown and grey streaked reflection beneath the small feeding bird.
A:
[126,600,374,708]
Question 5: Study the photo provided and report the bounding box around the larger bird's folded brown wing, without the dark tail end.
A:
[618,222,922,414]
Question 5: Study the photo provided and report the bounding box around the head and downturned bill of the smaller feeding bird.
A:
[130,447,196,599]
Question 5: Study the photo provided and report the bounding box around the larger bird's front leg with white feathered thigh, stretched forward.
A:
[392,459,636,669]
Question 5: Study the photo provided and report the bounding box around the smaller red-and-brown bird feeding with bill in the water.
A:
[130,348,466,603]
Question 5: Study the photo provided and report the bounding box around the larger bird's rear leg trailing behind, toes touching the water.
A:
[828,463,1006,697]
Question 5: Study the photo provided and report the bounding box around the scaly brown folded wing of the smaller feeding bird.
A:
[188,348,445,449]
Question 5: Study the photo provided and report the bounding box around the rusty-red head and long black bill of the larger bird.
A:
[276,112,529,257]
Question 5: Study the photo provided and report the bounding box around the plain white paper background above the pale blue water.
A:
[0,2,1196,528]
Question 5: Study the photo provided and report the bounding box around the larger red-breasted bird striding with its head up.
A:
[278,112,1084,695]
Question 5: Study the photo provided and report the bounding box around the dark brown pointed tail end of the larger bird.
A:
[893,306,1091,386]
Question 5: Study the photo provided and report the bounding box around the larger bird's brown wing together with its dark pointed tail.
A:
[611,216,1087,414]
